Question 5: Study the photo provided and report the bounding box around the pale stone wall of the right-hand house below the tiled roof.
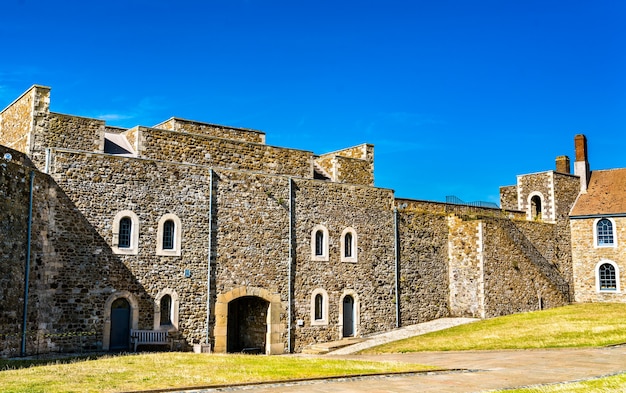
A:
[570,217,626,303]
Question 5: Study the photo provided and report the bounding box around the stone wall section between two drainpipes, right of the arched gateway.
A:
[293,179,396,351]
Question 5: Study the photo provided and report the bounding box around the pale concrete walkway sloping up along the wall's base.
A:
[330,318,479,355]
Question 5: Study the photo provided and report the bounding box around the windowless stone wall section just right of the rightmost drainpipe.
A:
[398,208,450,326]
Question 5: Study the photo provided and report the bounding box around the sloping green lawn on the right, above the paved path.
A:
[361,303,626,354]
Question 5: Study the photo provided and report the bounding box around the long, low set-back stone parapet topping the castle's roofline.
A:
[154,117,265,144]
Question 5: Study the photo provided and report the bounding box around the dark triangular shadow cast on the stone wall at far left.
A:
[0,166,154,356]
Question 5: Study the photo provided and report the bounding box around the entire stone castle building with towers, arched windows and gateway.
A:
[0,86,626,356]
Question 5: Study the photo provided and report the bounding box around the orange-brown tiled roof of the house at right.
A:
[570,168,626,216]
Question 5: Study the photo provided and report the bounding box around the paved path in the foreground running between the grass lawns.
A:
[188,347,626,393]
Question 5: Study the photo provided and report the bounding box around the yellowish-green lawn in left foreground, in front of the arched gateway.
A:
[0,352,432,393]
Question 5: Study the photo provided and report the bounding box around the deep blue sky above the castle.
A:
[0,0,626,202]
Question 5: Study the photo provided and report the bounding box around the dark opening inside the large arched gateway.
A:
[226,296,270,354]
